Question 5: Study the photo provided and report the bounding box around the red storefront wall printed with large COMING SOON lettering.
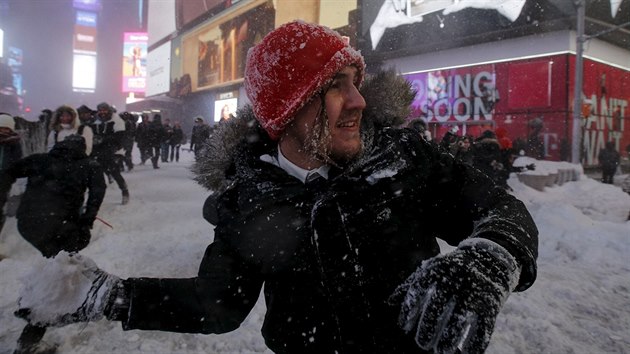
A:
[404,54,630,165]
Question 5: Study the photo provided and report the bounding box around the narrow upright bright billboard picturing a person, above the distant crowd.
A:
[122,32,149,93]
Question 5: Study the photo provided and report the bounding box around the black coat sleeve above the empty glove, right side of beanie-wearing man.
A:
[420,134,538,291]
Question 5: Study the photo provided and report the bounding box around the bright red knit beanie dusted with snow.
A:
[245,20,365,140]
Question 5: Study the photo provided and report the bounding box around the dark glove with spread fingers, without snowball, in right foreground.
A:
[390,238,520,353]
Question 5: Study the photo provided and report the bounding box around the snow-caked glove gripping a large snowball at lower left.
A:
[16,252,121,327]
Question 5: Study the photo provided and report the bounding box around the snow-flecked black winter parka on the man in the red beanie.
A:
[110,109,538,353]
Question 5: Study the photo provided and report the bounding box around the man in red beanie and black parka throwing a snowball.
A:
[13,21,538,353]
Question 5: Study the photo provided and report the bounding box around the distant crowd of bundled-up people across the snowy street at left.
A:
[0,102,220,210]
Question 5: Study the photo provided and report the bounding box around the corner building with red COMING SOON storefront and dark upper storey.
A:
[360,0,630,166]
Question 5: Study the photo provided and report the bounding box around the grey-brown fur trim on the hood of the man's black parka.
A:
[191,69,415,191]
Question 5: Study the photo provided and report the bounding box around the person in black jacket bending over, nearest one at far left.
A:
[0,135,106,353]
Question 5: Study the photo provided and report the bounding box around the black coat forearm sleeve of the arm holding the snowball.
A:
[111,241,262,334]
